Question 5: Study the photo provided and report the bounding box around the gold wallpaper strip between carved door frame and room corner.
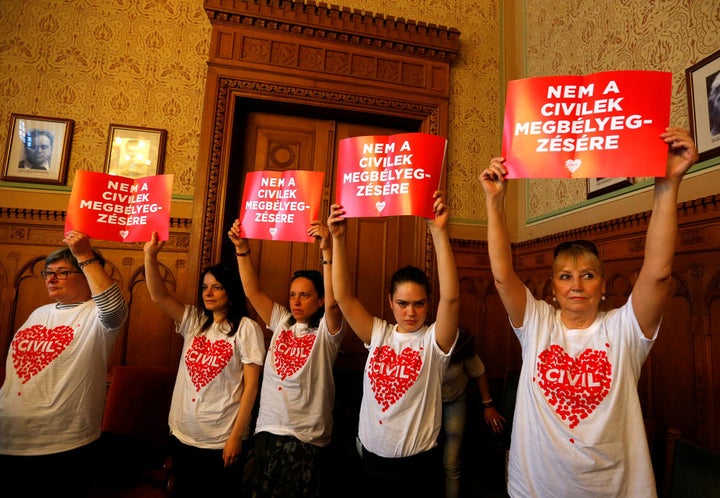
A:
[341,0,501,222]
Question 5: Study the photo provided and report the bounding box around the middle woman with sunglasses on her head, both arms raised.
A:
[228,220,345,498]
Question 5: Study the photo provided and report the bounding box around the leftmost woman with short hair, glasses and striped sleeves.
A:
[0,230,128,497]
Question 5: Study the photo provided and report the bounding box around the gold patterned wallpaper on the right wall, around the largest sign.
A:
[525,0,720,218]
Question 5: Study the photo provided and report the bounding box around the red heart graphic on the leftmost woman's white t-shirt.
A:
[12,325,75,384]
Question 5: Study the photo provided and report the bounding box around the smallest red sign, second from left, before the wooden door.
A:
[240,170,325,242]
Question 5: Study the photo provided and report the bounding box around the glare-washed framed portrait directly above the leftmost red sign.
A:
[105,124,167,178]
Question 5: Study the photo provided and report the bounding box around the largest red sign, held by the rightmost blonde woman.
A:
[502,71,672,178]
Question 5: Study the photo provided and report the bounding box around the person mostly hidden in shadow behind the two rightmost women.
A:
[442,329,505,498]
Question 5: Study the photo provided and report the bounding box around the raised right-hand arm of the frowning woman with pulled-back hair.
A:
[427,192,460,353]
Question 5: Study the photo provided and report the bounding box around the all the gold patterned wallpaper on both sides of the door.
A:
[0,0,720,225]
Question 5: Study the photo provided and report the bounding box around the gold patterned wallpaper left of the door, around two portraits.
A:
[0,0,210,195]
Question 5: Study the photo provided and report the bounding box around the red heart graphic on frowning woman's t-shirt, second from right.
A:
[368,346,422,411]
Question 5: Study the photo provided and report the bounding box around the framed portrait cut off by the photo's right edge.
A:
[685,50,720,161]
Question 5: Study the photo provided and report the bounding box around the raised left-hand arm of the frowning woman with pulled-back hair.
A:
[328,204,373,344]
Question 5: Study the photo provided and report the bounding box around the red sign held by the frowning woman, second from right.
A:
[335,133,447,218]
